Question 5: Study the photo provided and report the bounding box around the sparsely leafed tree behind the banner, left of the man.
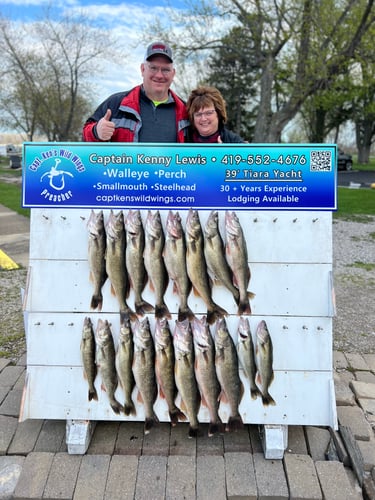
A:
[0,11,118,141]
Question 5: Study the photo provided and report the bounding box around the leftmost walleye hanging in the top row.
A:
[87,210,107,311]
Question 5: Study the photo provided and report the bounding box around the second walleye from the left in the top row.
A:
[106,210,136,321]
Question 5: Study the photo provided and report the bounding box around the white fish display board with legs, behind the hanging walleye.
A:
[20,208,337,458]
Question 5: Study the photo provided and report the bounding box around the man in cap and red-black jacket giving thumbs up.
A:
[83,42,189,142]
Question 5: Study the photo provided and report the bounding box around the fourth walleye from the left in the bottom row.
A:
[132,316,159,434]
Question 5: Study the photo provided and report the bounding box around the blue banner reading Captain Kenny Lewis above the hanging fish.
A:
[22,142,337,210]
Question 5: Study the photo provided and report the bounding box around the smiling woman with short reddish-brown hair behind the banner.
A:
[186,86,247,143]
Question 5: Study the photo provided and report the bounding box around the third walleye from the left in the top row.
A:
[125,210,154,316]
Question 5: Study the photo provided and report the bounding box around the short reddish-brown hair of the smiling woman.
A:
[186,86,227,125]
